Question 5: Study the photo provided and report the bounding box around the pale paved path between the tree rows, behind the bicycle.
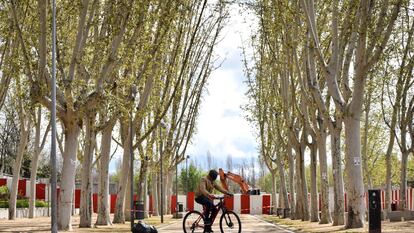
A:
[158,214,291,233]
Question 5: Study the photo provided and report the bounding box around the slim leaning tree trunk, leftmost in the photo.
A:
[9,122,30,220]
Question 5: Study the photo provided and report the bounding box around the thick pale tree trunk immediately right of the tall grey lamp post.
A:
[58,123,80,231]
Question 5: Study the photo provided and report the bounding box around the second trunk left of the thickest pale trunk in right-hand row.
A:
[317,131,331,224]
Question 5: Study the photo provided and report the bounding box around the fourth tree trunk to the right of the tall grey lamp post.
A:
[112,122,131,223]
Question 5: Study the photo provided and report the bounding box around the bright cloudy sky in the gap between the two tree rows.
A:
[188,5,257,169]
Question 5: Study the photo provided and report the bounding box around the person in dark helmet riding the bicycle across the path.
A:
[195,170,232,232]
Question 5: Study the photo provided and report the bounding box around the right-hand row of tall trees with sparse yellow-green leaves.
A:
[246,0,414,228]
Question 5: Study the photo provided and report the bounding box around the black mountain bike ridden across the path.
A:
[183,196,241,233]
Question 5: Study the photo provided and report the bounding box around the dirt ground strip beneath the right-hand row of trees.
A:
[261,215,414,233]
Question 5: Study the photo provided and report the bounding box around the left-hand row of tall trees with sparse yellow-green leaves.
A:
[0,0,227,230]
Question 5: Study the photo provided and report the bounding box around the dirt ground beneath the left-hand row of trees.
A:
[0,214,176,233]
